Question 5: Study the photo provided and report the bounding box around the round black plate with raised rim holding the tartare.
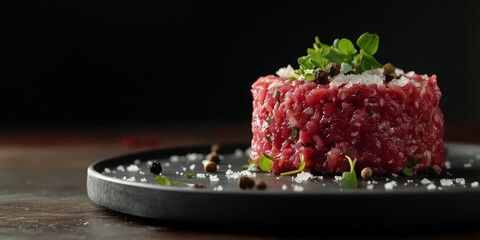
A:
[87,142,480,228]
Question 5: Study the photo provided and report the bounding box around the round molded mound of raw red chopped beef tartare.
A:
[250,73,445,174]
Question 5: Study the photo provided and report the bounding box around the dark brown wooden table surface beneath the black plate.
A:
[0,123,480,239]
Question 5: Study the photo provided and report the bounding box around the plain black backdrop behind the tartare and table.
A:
[0,1,480,125]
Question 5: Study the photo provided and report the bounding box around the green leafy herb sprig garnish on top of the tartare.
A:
[292,32,382,81]
